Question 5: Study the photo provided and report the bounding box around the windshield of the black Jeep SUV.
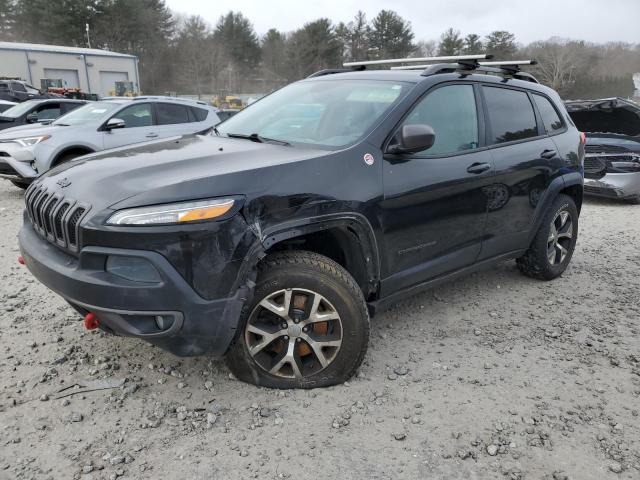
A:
[218,80,411,149]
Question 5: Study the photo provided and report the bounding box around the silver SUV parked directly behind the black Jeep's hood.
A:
[0,96,220,188]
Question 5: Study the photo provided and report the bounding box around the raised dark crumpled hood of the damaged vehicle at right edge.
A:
[565,98,640,137]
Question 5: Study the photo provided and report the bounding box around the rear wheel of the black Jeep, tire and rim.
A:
[516,194,578,280]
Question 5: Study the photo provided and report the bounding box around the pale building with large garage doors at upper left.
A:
[0,42,140,96]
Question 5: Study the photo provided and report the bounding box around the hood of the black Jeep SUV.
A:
[32,135,327,216]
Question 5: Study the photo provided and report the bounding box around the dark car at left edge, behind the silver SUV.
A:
[0,98,87,130]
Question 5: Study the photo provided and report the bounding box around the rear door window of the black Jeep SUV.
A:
[482,87,538,143]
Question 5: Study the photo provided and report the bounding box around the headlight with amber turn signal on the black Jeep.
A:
[107,198,235,225]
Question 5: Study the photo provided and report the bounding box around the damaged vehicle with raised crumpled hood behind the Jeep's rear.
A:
[565,98,640,203]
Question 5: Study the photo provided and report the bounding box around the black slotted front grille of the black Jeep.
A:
[25,185,89,252]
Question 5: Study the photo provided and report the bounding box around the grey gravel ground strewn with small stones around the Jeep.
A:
[0,182,640,480]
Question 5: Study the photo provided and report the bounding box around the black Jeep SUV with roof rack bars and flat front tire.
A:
[20,59,584,388]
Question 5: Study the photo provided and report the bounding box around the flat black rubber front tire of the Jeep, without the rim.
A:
[227,253,369,388]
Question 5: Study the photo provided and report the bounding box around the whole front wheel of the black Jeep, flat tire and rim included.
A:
[226,251,369,389]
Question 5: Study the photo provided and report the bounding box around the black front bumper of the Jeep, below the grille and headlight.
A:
[19,222,247,356]
